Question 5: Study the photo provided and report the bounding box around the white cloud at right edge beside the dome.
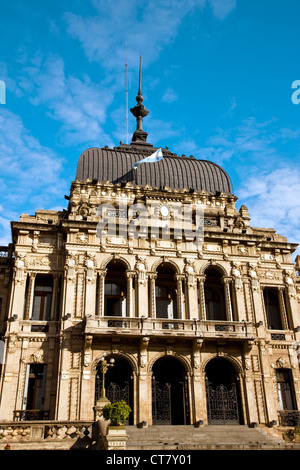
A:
[188,117,300,253]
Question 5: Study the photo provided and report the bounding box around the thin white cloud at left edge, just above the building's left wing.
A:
[0,108,66,242]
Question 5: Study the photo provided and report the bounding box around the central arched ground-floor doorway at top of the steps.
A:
[152,357,190,425]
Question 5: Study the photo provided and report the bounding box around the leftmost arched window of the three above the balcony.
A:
[104,261,127,317]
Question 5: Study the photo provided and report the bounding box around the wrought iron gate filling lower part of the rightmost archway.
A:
[206,384,239,424]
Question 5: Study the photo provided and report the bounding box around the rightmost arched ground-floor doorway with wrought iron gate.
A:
[205,358,243,424]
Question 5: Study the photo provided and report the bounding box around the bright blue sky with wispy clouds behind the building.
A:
[0,0,300,258]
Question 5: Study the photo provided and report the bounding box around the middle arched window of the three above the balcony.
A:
[155,263,177,319]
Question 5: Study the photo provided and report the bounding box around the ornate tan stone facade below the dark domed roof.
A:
[0,165,300,425]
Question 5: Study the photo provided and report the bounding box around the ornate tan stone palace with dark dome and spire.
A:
[0,70,300,448]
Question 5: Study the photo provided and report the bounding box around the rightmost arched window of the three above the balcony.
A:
[204,268,226,321]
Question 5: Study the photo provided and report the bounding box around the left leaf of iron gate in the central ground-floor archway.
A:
[152,379,172,424]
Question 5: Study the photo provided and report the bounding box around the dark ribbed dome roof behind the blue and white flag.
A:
[76,144,232,194]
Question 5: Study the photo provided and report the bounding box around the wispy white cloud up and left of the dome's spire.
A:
[19,55,115,144]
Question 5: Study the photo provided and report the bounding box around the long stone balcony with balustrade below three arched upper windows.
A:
[85,316,256,340]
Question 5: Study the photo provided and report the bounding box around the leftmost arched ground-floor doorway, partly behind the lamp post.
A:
[95,355,133,424]
